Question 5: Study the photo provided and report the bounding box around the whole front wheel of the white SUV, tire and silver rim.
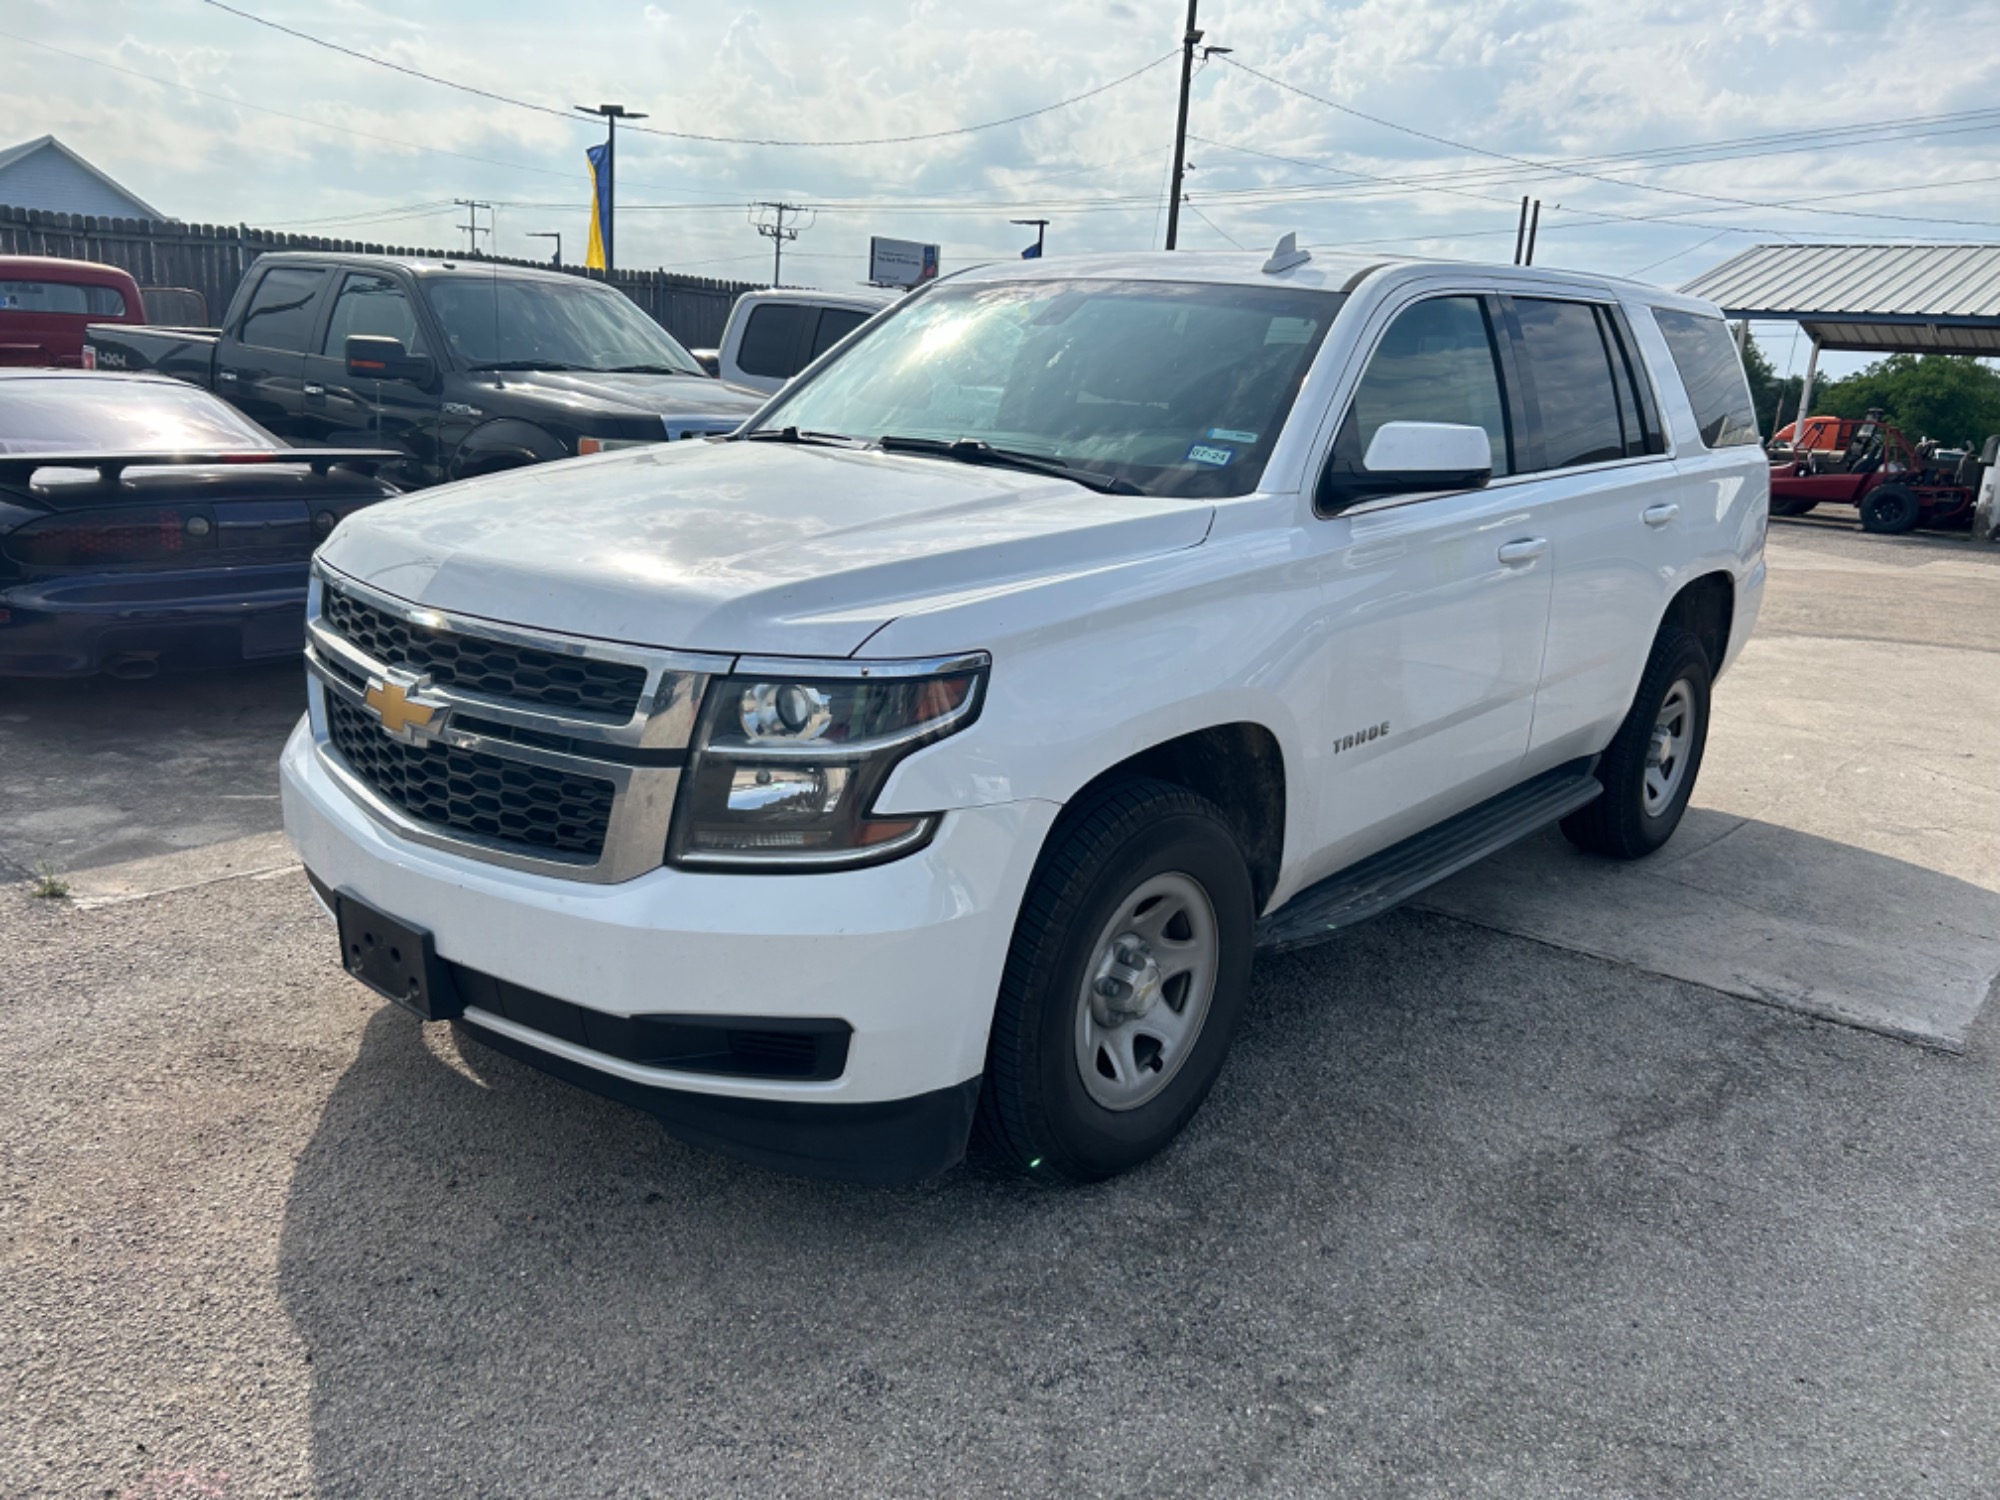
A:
[978,780,1256,1182]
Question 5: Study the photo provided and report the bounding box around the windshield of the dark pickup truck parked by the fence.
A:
[424,276,708,380]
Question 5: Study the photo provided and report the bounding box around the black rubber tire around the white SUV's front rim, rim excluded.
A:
[974,778,1256,1182]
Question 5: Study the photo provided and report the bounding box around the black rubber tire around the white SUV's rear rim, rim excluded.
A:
[1562,628,1714,860]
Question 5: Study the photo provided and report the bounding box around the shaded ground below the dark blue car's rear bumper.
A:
[0,660,306,874]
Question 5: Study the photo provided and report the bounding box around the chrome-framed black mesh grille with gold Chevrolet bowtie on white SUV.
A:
[306,564,730,882]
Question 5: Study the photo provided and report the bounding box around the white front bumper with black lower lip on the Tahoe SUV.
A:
[282,722,1058,1180]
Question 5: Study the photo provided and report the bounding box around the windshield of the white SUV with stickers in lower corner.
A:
[758,280,1346,496]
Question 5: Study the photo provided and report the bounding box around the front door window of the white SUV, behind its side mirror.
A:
[1334,296,1514,474]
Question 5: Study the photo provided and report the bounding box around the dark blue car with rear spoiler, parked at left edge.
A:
[0,370,396,678]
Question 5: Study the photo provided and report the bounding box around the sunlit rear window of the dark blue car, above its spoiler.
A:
[0,376,284,454]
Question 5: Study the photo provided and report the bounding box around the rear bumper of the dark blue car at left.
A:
[0,562,306,676]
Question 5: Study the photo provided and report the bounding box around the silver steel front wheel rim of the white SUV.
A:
[1076,872,1220,1110]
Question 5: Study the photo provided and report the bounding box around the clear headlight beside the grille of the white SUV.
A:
[668,654,988,870]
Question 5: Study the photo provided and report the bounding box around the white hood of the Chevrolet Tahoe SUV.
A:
[320,442,1214,656]
